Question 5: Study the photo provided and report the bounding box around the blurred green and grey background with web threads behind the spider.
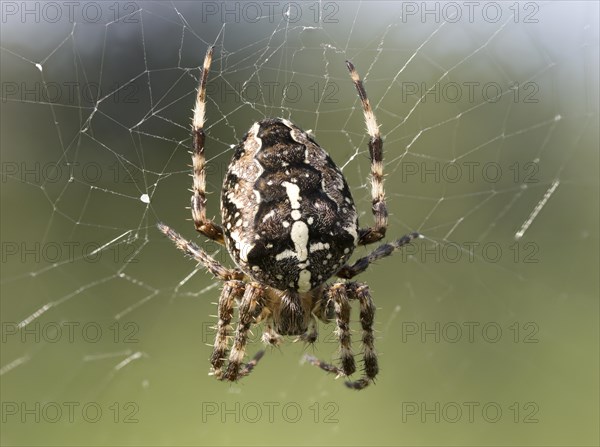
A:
[0,2,599,445]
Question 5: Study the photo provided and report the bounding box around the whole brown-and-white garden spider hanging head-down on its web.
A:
[158,47,420,390]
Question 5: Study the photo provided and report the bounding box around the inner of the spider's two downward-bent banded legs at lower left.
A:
[221,282,265,382]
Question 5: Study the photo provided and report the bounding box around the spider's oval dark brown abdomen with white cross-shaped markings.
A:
[221,118,358,293]
